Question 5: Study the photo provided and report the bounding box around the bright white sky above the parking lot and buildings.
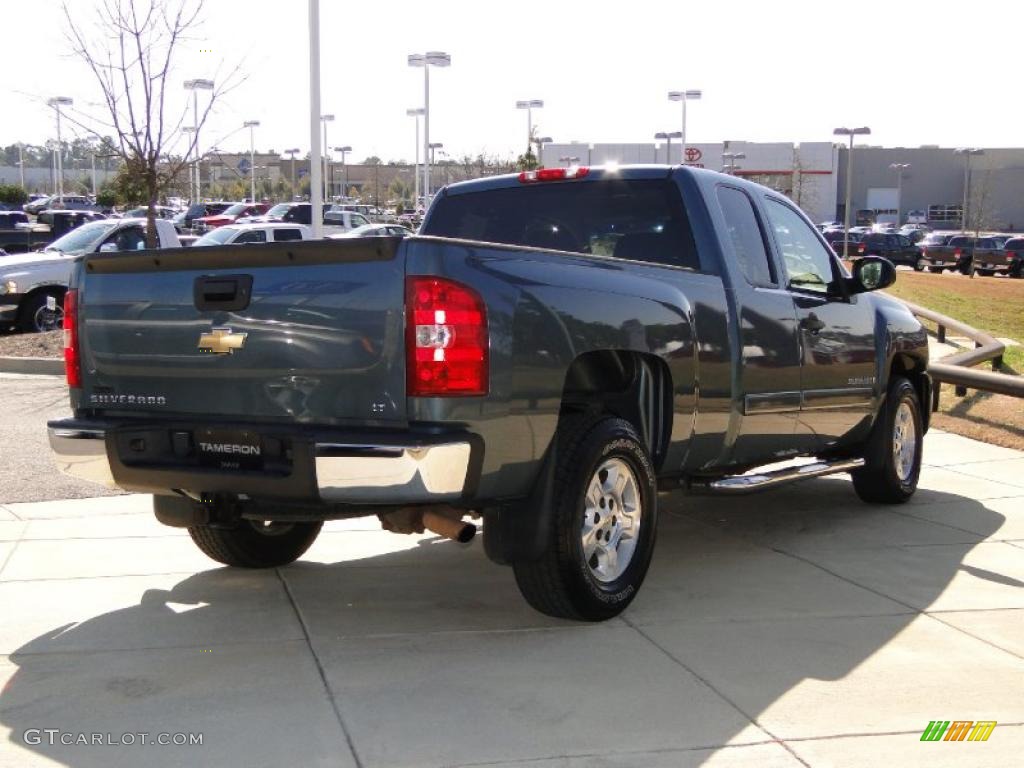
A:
[0,0,1024,162]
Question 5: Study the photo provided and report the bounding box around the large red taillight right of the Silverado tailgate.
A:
[406,276,488,396]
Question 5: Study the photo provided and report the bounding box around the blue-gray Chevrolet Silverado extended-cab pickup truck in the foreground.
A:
[49,166,931,621]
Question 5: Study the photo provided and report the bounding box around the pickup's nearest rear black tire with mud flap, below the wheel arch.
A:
[513,417,657,622]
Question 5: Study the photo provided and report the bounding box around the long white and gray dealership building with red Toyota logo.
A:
[541,141,1024,231]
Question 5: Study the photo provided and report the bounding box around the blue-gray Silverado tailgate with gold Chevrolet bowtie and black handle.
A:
[79,238,406,425]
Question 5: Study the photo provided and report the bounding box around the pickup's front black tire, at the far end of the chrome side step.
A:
[851,376,925,504]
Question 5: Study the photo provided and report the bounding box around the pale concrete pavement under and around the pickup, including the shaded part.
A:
[0,372,1024,768]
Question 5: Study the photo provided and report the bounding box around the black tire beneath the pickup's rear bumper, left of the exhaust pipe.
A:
[188,520,324,568]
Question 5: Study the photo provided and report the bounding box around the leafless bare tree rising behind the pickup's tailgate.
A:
[63,0,242,243]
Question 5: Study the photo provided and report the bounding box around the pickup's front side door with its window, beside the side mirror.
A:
[764,197,876,451]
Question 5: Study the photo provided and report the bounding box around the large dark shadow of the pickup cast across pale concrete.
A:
[0,478,1022,768]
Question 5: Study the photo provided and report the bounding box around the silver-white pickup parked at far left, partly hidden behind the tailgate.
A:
[0,219,179,332]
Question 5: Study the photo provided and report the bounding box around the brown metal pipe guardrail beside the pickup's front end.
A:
[903,301,1024,411]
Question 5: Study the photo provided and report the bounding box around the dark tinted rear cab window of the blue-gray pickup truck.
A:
[422,179,700,270]
